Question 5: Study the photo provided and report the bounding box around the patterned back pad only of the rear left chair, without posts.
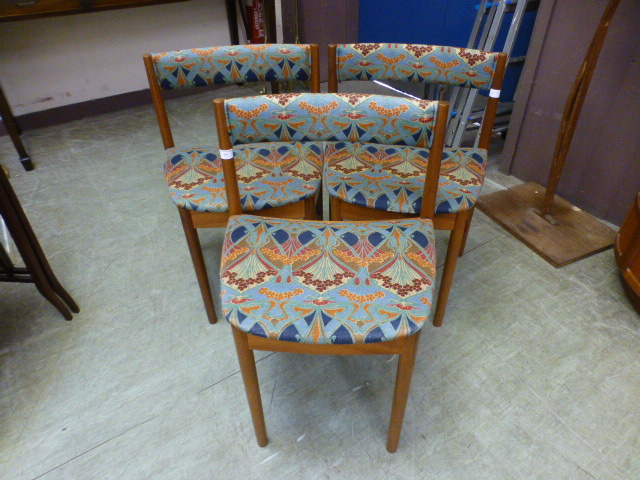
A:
[153,44,311,90]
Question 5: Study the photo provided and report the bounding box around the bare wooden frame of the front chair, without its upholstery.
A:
[214,94,449,453]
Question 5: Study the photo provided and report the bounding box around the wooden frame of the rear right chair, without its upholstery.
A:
[328,44,507,327]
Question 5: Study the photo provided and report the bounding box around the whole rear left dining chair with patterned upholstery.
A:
[143,44,321,323]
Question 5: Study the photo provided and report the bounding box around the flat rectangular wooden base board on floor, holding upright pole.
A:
[478,182,616,268]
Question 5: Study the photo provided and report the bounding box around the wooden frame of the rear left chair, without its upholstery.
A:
[143,44,320,324]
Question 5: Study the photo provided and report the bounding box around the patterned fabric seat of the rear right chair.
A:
[324,142,487,214]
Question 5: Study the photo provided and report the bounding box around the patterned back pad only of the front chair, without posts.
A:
[225,93,438,148]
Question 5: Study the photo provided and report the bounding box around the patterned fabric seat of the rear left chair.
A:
[165,142,322,212]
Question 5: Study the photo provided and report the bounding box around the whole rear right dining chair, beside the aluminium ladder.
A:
[323,43,507,327]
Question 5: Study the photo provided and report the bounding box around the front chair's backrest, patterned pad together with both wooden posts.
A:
[214,93,449,218]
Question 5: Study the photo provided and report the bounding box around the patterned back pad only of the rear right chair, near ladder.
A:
[337,43,498,90]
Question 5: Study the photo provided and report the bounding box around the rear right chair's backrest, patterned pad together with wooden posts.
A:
[329,43,507,149]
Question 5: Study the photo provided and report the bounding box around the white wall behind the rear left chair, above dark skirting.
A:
[0,0,231,115]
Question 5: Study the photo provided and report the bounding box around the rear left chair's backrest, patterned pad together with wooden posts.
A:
[143,44,320,148]
